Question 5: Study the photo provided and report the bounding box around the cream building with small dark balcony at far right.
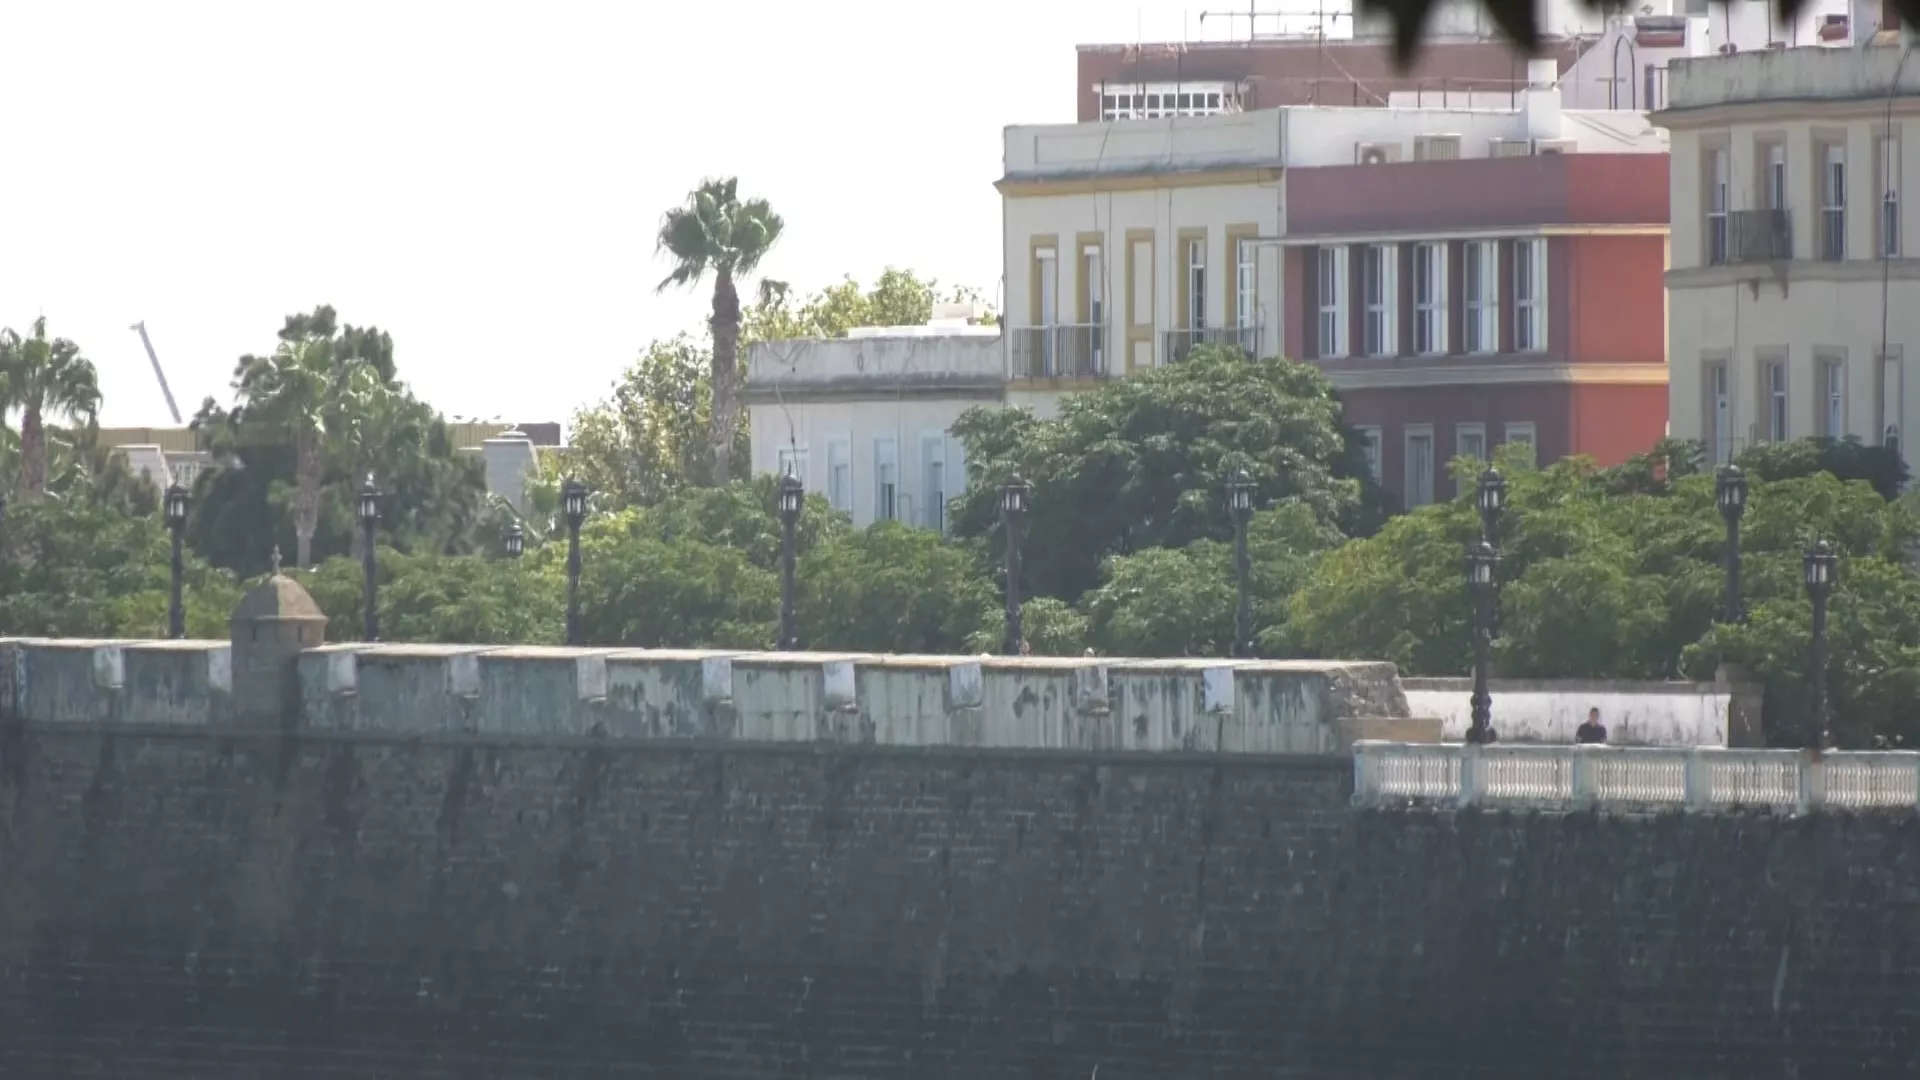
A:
[1655,35,1920,461]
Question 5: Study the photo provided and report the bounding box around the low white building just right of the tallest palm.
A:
[745,321,1006,532]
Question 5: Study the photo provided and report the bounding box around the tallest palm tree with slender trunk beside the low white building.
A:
[655,177,783,484]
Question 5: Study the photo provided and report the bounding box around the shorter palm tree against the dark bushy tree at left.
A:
[234,334,384,567]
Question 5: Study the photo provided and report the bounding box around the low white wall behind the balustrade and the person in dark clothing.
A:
[1400,678,1728,746]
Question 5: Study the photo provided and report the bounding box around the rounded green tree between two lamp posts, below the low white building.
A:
[795,521,998,653]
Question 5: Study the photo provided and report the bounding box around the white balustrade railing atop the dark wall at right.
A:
[1354,742,1920,813]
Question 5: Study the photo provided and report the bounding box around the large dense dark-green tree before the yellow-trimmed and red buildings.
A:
[952,348,1379,600]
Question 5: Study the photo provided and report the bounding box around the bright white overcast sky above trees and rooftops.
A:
[0,0,1320,425]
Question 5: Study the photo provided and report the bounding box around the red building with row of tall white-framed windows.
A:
[1283,154,1668,505]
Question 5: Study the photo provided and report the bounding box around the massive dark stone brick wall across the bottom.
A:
[0,726,1920,1080]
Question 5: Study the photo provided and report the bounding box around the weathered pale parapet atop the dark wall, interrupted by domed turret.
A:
[0,638,1430,753]
